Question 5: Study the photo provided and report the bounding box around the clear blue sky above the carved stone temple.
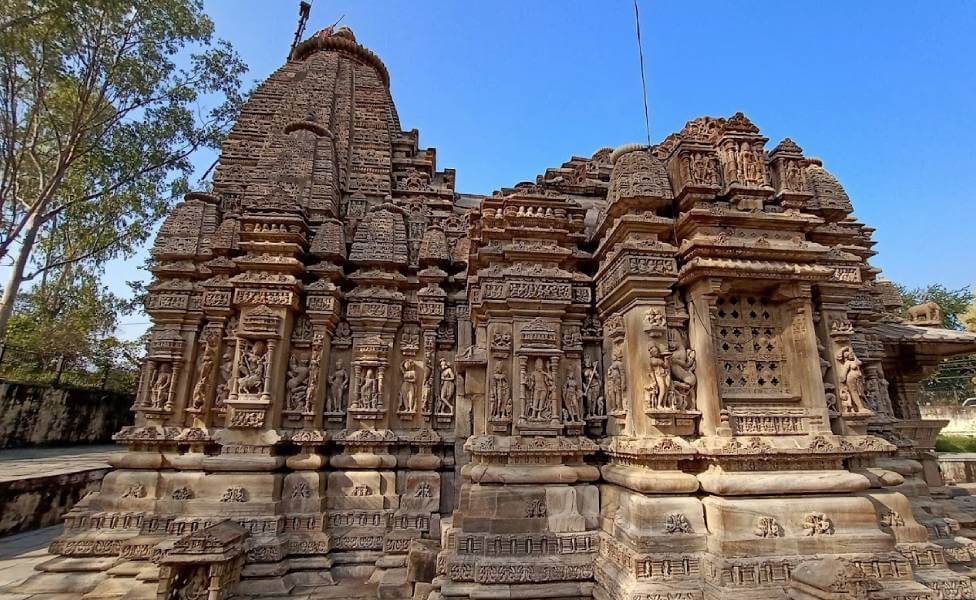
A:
[109,0,976,333]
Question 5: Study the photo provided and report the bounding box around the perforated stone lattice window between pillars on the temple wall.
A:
[713,295,789,399]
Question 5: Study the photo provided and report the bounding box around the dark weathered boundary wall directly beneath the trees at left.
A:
[0,381,133,449]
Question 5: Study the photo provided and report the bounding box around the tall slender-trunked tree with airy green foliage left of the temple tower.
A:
[0,0,246,337]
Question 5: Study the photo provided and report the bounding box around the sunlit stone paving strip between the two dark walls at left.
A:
[0,444,119,482]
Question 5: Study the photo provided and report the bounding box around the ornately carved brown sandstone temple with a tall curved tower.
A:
[13,29,976,600]
